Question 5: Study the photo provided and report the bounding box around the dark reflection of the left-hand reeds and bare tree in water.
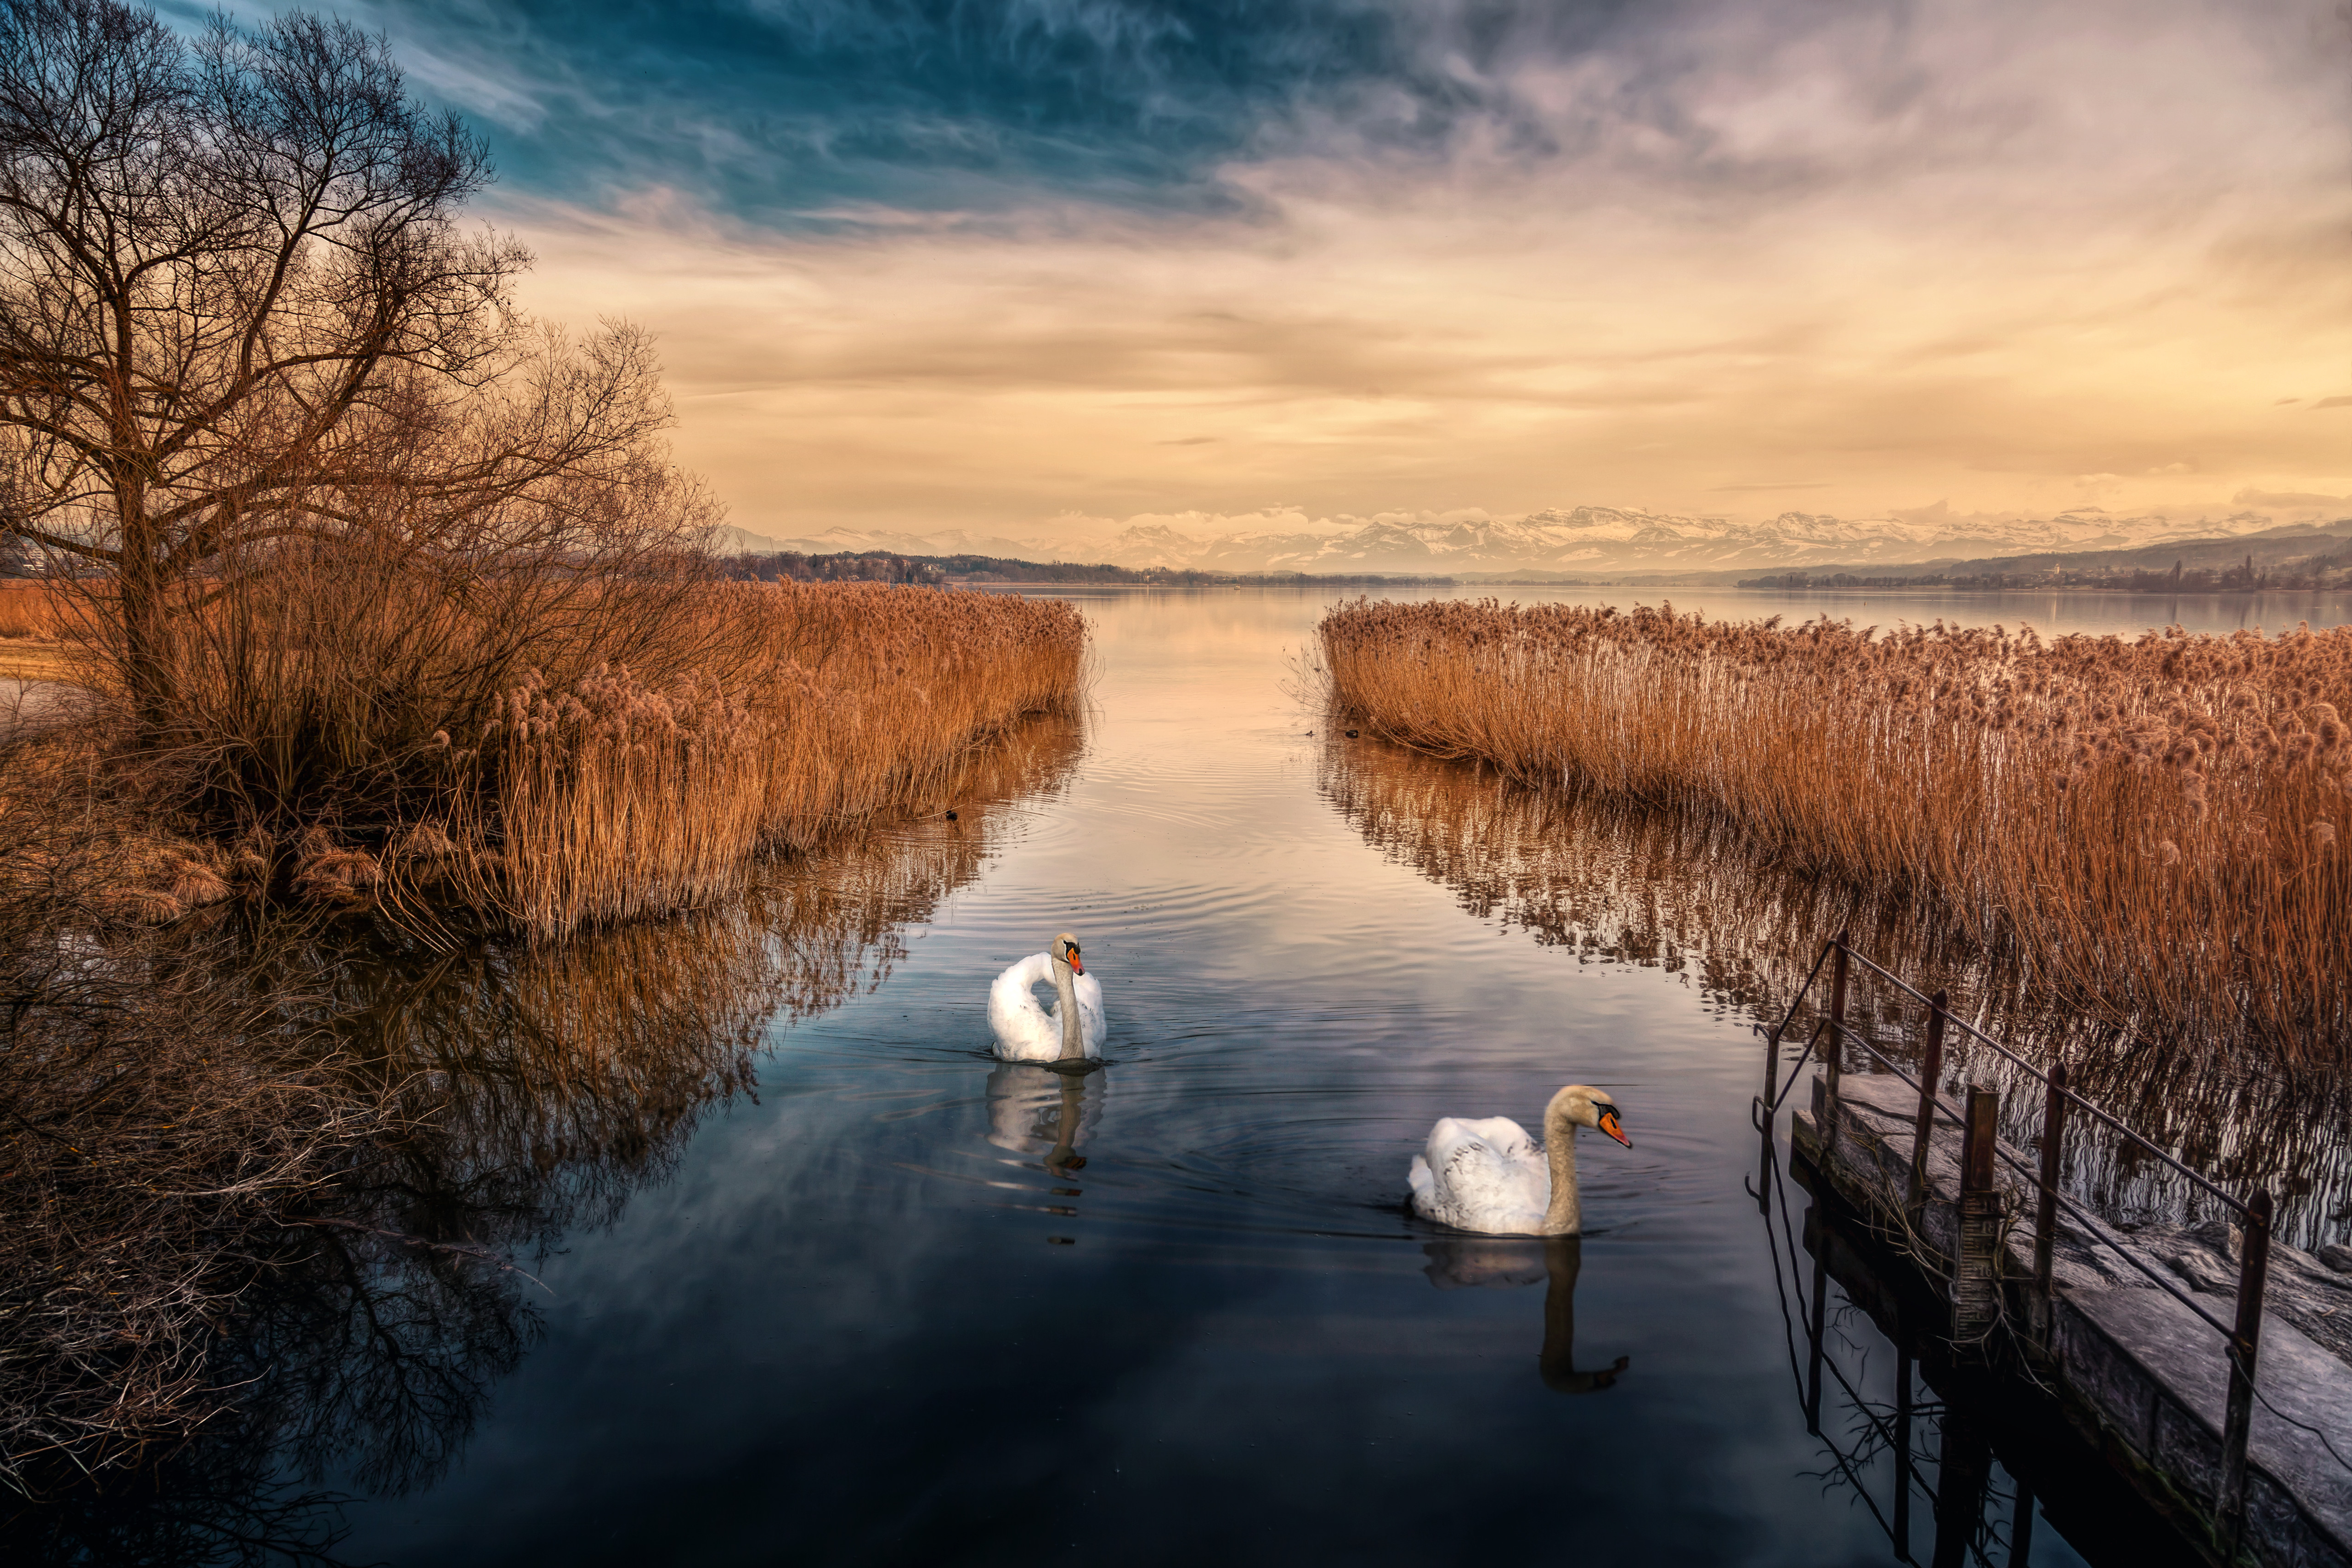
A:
[0,717,1082,1563]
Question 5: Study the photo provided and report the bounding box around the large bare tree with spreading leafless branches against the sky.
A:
[0,0,703,736]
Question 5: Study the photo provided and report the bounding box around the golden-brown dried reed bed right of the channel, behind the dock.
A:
[1322,600,2352,1072]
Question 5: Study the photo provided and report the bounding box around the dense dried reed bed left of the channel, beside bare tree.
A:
[494,583,1086,933]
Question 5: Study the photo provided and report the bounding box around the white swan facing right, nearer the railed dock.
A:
[1407,1084,1632,1237]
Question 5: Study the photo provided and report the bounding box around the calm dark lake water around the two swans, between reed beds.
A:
[78,590,2352,1568]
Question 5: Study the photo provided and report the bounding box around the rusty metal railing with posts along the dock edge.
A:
[1755,931,2272,1530]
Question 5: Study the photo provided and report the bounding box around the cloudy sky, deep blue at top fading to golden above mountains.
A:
[165,0,2352,538]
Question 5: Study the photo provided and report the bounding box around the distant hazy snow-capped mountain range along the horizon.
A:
[739,505,2342,576]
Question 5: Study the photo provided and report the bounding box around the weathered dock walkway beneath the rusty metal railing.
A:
[1797,1072,2352,1568]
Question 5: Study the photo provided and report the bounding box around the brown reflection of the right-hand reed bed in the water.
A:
[1319,738,2352,1251]
